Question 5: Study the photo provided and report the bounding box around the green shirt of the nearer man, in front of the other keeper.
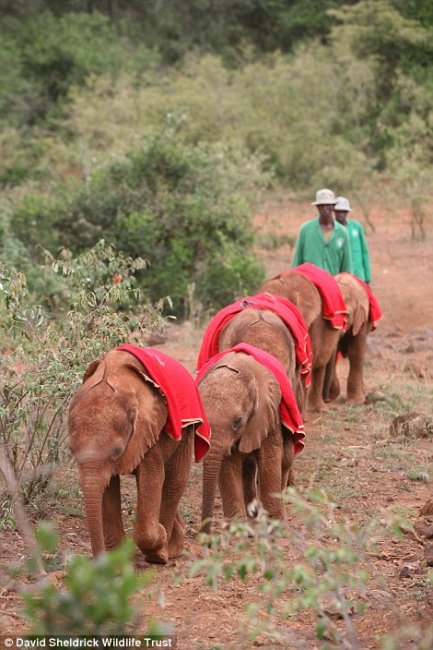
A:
[292,217,352,275]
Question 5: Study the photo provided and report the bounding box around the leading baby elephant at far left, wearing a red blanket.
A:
[69,345,209,564]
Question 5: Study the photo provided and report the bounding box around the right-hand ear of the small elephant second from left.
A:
[239,362,281,454]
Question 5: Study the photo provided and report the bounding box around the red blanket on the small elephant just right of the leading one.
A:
[196,343,305,454]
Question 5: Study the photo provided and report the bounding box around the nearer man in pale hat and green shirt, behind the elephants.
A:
[292,189,352,275]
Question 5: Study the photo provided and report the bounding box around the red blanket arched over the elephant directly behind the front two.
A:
[197,293,312,386]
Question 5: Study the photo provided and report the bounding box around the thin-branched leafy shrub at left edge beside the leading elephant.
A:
[0,242,159,502]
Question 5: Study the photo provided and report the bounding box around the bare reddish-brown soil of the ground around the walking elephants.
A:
[0,204,433,650]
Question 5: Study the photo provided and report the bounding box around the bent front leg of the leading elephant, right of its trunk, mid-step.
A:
[134,443,168,564]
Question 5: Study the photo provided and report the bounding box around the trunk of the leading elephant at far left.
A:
[80,468,107,558]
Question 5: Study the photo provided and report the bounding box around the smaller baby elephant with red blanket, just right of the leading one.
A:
[197,343,304,532]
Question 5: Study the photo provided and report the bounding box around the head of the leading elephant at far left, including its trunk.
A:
[69,350,167,556]
